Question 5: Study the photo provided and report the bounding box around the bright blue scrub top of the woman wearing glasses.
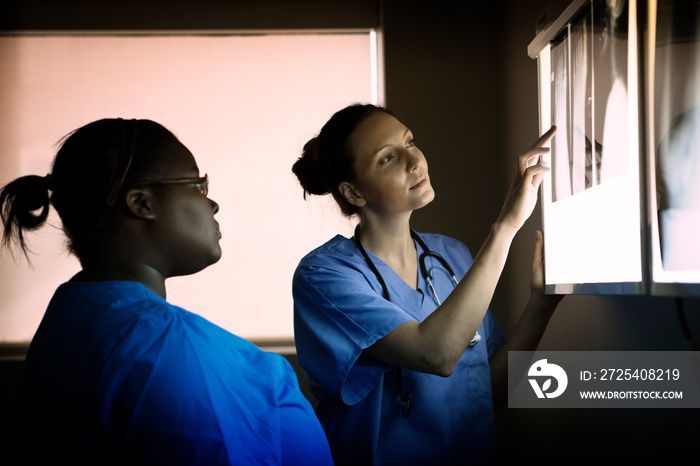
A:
[20,282,332,466]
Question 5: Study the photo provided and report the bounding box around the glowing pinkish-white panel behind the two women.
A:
[0,30,378,342]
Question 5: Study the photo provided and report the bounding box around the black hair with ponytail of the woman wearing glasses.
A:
[0,118,179,258]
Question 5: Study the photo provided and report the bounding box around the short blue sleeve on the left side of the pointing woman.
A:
[292,249,415,405]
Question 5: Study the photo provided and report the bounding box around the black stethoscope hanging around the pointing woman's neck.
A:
[354,225,481,417]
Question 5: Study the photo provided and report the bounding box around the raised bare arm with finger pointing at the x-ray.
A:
[365,127,556,376]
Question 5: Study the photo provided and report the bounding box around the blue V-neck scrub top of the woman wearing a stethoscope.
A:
[293,234,503,466]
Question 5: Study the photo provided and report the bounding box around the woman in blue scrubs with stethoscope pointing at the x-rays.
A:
[293,105,560,465]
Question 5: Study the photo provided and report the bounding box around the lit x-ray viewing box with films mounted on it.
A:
[528,0,700,296]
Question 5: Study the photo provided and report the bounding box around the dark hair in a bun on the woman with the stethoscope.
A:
[292,104,392,216]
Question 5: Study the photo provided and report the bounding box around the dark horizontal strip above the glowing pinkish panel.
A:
[0,0,377,30]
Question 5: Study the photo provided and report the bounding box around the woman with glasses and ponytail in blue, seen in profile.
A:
[0,119,332,465]
